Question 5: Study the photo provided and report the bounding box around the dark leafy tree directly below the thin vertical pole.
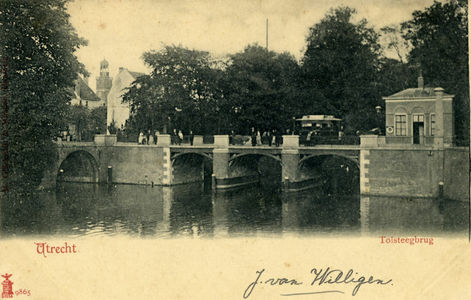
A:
[224,45,299,133]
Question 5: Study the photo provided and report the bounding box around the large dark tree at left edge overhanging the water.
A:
[0,0,86,190]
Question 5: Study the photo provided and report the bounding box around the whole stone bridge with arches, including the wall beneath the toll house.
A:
[43,135,469,199]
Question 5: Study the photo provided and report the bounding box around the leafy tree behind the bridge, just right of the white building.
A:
[123,46,223,133]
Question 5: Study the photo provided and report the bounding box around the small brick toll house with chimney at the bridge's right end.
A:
[383,75,454,146]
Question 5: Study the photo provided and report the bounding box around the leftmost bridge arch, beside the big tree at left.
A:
[57,150,99,183]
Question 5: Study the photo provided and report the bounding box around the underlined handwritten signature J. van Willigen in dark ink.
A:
[244,267,392,299]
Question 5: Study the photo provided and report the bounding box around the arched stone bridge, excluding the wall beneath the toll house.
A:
[44,135,360,190]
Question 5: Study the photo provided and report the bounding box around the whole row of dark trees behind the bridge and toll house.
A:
[123,1,469,139]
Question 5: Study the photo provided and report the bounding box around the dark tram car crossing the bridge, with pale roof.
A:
[296,115,343,146]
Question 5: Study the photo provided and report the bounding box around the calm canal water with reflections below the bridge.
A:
[0,183,469,239]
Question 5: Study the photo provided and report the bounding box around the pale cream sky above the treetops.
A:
[68,0,433,90]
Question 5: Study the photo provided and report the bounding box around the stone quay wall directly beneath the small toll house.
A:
[360,147,470,201]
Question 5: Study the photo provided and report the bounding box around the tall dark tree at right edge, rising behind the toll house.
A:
[401,0,469,142]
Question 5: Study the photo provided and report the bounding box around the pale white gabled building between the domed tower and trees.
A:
[106,68,144,132]
